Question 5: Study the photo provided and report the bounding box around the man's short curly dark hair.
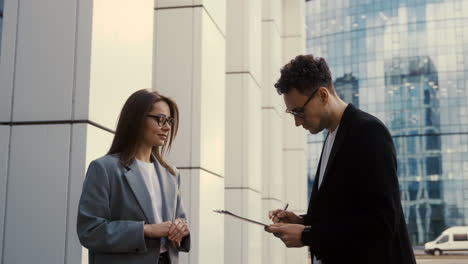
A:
[275,55,335,95]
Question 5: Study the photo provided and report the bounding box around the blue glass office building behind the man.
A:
[306,0,468,244]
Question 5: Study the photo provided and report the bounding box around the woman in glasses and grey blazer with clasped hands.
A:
[77,90,190,264]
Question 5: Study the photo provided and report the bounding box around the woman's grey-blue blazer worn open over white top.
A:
[77,155,190,264]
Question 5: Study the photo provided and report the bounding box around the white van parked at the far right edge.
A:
[424,226,468,256]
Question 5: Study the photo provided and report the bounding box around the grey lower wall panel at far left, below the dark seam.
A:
[3,125,72,263]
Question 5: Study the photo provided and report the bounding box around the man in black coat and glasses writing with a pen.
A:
[266,55,416,264]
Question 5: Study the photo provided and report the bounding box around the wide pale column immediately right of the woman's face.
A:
[153,0,226,264]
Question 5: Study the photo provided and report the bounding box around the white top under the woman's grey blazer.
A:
[136,159,167,253]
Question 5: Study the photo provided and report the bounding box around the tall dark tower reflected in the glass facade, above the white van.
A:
[384,56,445,243]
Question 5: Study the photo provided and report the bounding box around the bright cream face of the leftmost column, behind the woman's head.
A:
[80,0,154,261]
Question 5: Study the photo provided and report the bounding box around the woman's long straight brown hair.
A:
[107,89,179,175]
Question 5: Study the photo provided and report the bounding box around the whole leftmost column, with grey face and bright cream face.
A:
[0,0,154,263]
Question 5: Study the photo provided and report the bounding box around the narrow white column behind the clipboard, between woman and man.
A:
[224,0,264,264]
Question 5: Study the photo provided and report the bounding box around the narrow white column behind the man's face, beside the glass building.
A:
[282,0,309,263]
